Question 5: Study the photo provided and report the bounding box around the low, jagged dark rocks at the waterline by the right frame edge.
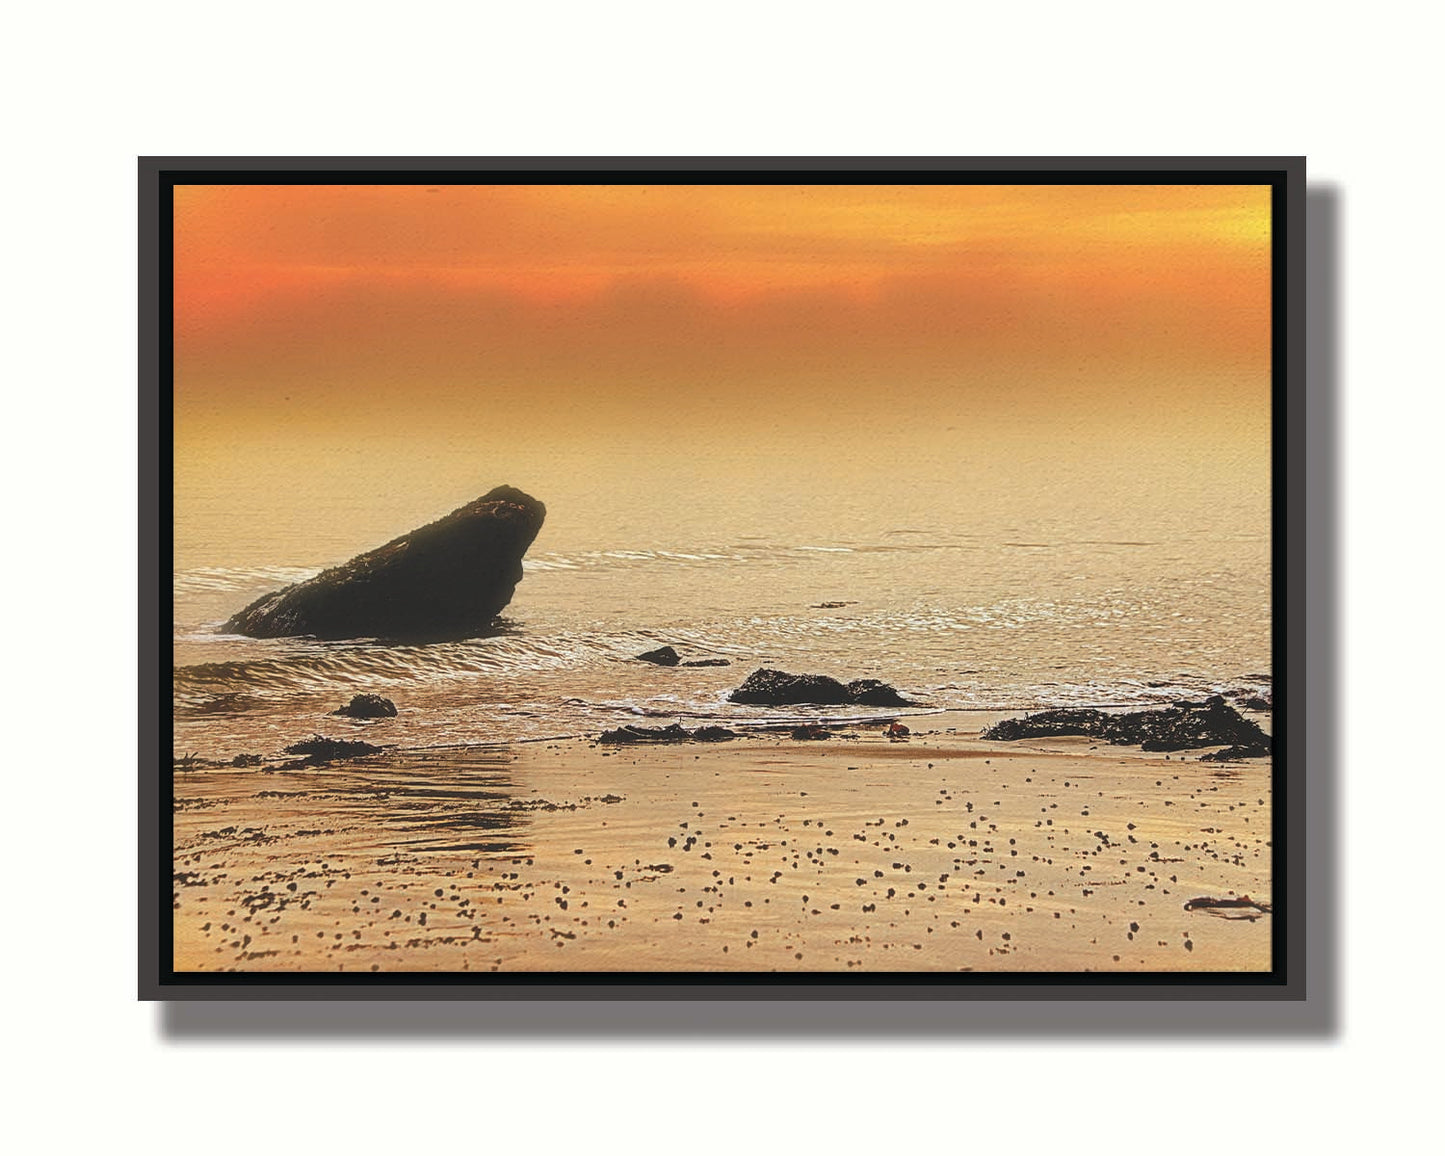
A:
[980,695,1270,759]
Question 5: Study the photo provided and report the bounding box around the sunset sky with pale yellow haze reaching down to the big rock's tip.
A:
[175,185,1270,569]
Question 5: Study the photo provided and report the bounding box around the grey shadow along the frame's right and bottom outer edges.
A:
[152,178,1341,1045]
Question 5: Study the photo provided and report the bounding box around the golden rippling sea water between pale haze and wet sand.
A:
[173,468,1270,759]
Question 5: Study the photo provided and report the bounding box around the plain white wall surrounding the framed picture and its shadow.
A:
[8,0,1442,1152]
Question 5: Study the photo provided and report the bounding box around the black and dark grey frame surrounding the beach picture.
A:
[137,156,1312,1001]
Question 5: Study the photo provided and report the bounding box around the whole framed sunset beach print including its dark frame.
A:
[140,158,1303,998]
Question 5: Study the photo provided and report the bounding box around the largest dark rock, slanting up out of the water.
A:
[225,486,546,642]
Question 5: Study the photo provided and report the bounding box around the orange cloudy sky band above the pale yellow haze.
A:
[175,185,1270,439]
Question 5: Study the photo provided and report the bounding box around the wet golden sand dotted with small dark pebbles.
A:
[172,712,1272,972]
